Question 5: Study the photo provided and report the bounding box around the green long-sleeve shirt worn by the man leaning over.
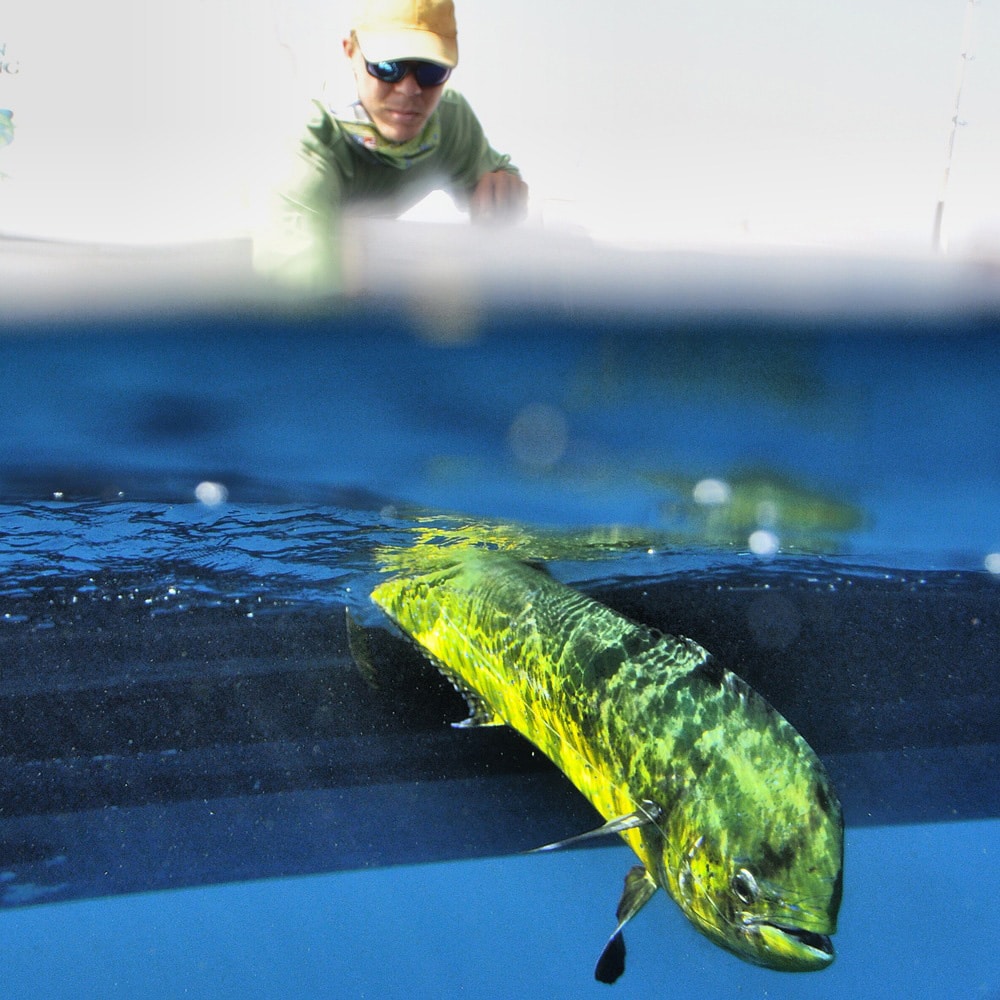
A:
[254,90,517,291]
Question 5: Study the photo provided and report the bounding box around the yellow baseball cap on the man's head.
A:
[354,0,458,66]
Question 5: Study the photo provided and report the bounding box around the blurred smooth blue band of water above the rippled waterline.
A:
[0,312,1000,569]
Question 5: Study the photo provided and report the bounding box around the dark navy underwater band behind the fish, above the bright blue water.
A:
[0,557,1000,906]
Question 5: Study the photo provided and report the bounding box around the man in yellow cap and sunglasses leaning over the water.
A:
[254,0,528,291]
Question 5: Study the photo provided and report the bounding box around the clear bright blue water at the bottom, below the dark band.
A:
[3,821,1000,1000]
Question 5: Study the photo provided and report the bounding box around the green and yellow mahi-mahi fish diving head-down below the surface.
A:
[372,546,843,982]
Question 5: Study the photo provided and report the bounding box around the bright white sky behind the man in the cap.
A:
[0,0,1000,253]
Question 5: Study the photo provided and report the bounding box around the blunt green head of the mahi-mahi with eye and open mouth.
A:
[650,689,843,972]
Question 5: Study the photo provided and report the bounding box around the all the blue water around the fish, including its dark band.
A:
[0,303,1000,998]
